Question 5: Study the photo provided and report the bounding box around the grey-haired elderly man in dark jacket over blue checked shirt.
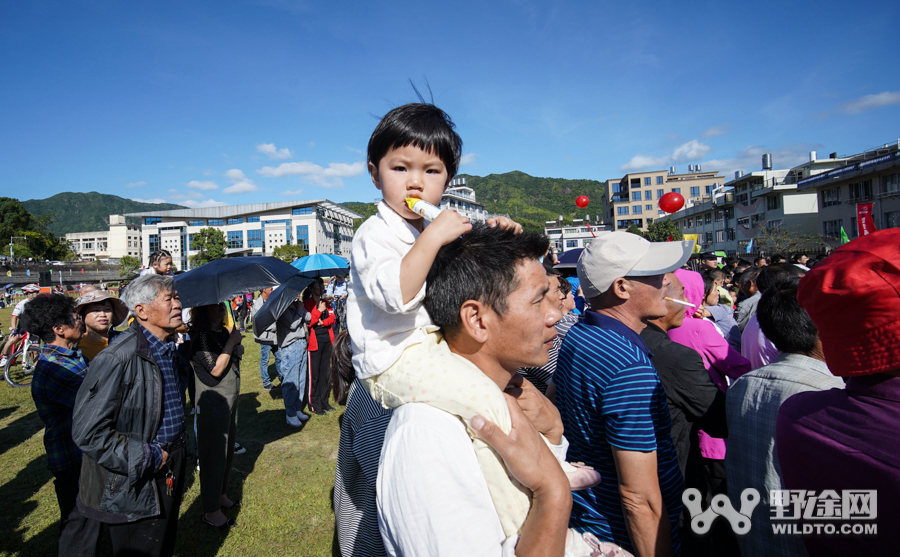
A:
[72,274,186,556]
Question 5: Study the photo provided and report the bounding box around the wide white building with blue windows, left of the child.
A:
[127,199,362,270]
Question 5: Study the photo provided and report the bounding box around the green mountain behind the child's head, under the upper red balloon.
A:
[342,170,606,232]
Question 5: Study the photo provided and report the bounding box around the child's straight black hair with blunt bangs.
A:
[368,103,462,179]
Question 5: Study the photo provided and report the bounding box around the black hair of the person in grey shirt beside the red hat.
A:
[756,276,819,354]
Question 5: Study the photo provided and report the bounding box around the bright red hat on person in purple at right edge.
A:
[797,228,900,377]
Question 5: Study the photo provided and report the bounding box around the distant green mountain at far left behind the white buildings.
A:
[22,191,187,237]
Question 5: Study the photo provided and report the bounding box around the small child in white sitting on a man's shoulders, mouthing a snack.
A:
[347,104,597,535]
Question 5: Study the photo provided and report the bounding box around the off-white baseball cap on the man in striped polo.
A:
[578,231,694,299]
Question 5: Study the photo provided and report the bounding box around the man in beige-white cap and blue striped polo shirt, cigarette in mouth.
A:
[553,232,693,556]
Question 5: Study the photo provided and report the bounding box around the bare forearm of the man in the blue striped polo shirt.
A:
[612,447,672,557]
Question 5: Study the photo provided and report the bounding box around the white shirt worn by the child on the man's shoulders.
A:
[347,201,431,379]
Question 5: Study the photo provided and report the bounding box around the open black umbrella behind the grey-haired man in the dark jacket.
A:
[175,257,299,307]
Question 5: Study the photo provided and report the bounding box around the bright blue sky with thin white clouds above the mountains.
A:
[0,0,900,206]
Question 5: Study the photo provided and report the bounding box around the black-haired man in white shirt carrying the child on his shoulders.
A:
[376,227,586,556]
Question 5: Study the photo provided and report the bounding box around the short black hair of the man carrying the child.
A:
[425,223,550,336]
